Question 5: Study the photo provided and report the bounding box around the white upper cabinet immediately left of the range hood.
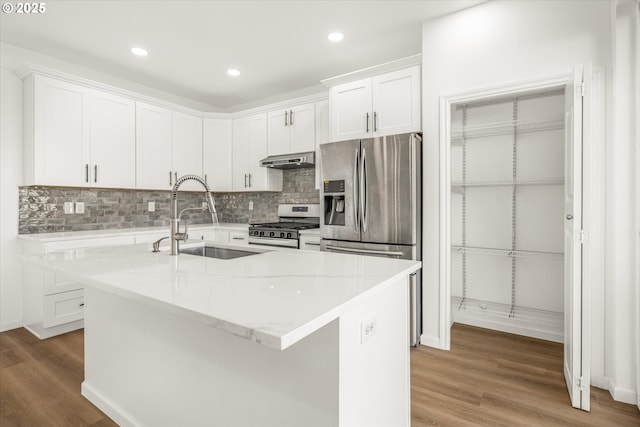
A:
[232,113,282,191]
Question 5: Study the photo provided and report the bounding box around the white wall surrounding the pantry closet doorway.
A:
[422,1,635,401]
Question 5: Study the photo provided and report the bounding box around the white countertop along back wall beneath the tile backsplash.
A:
[18,223,249,243]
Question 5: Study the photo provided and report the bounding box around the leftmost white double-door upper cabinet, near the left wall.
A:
[24,75,135,188]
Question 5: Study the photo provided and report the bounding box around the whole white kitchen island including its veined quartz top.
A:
[25,245,420,426]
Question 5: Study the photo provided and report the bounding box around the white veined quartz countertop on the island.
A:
[23,245,421,350]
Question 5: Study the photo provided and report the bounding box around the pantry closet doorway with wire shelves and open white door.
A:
[440,66,591,410]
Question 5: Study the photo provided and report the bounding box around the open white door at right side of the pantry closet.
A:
[564,66,590,410]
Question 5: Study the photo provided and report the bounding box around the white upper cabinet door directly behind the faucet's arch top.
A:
[171,111,203,191]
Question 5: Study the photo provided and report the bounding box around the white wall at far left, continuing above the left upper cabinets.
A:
[0,43,218,331]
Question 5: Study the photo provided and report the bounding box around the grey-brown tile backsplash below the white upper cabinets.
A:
[18,168,320,234]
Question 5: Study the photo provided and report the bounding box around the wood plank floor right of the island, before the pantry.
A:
[411,324,640,427]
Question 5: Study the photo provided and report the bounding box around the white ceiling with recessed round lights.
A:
[0,0,479,111]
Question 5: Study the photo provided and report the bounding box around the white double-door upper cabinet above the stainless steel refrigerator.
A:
[330,66,420,141]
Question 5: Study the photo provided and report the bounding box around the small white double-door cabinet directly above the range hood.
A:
[267,103,315,156]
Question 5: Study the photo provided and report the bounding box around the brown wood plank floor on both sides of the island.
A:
[0,325,640,427]
